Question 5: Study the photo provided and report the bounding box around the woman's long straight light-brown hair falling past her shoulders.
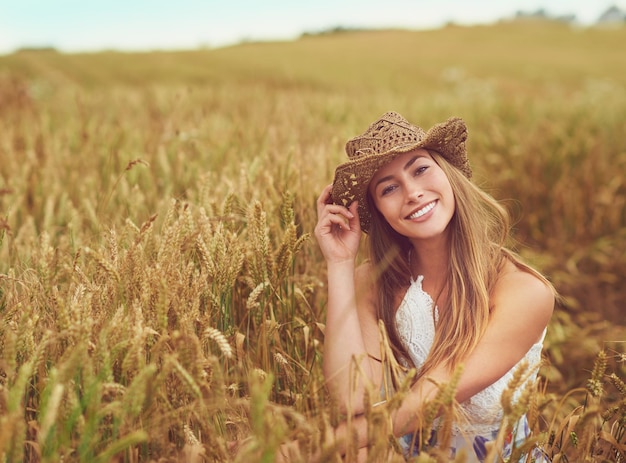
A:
[368,150,551,377]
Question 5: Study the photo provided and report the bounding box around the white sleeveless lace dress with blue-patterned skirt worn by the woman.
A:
[395,276,545,463]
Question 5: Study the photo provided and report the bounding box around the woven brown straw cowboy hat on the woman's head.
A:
[331,112,472,233]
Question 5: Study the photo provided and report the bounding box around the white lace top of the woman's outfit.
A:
[395,275,545,434]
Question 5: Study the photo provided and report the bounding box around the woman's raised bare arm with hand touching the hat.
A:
[315,185,382,414]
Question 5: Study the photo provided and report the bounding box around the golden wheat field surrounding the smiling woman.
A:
[0,22,626,463]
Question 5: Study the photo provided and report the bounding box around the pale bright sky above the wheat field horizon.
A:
[0,0,626,54]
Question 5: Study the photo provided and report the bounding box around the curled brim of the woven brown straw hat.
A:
[331,117,472,233]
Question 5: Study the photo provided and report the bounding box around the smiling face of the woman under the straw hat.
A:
[369,149,455,245]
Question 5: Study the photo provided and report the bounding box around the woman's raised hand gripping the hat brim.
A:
[315,185,361,263]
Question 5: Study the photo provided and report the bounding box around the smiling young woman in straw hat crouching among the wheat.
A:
[315,112,555,461]
